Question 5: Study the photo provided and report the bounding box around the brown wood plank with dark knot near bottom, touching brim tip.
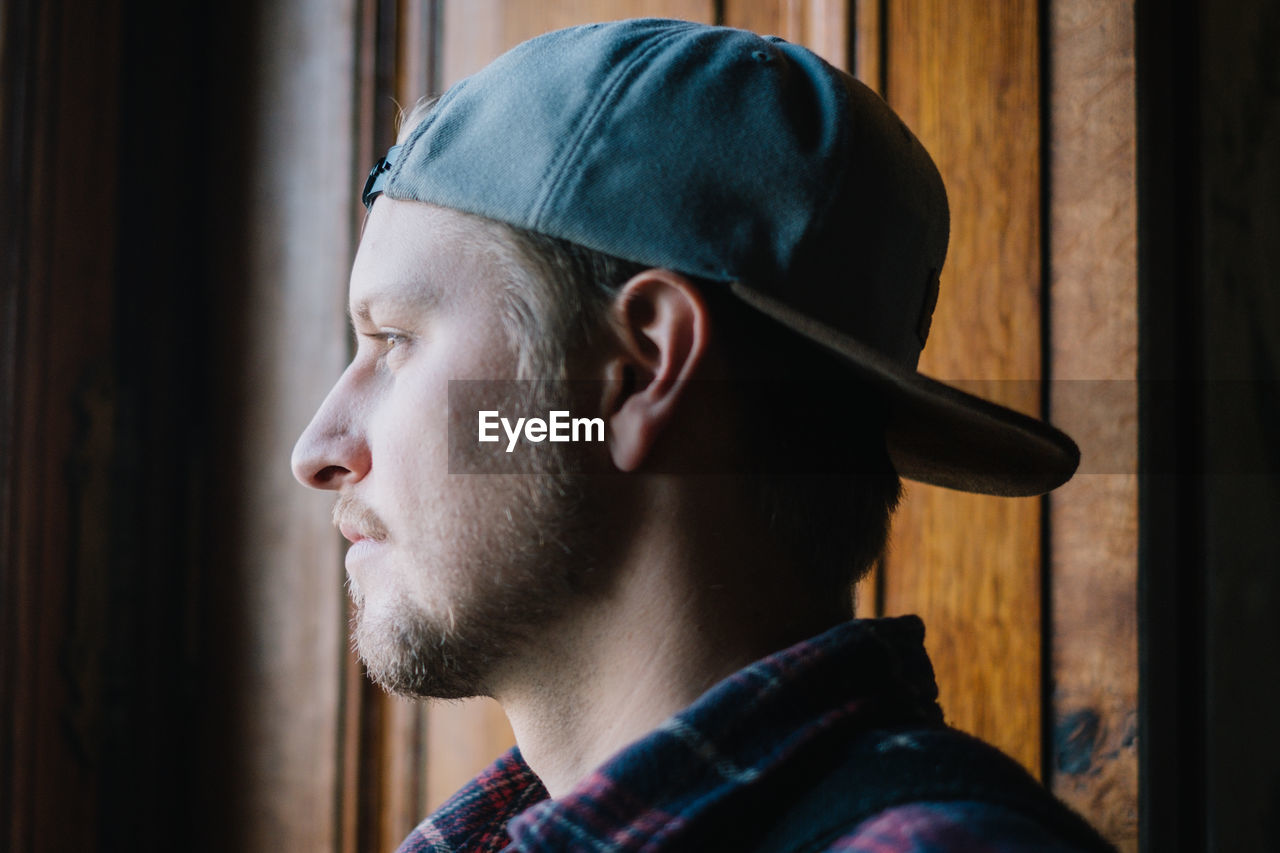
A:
[1048,0,1138,850]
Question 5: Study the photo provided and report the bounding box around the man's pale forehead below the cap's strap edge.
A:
[351,196,509,318]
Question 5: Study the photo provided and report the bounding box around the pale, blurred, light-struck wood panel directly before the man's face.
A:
[197,0,357,850]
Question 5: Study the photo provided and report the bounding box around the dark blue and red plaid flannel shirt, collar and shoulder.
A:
[398,616,1111,853]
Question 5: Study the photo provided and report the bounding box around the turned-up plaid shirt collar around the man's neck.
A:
[402,616,942,850]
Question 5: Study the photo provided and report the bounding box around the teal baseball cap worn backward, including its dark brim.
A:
[364,18,1079,496]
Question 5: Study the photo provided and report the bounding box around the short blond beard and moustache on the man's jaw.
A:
[334,379,594,699]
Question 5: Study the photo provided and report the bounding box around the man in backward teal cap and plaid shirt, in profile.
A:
[293,20,1105,850]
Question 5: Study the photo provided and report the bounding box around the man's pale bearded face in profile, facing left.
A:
[293,197,588,697]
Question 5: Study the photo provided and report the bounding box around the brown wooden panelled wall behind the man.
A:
[0,0,1218,852]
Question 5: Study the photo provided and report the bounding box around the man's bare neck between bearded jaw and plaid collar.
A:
[494,473,847,797]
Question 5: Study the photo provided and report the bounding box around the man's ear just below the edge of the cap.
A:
[604,269,710,471]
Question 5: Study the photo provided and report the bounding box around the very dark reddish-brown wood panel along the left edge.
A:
[0,3,122,852]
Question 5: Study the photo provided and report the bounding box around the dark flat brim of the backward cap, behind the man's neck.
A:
[730,282,1080,497]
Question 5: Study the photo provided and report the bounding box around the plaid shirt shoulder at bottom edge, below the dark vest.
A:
[823,800,1100,853]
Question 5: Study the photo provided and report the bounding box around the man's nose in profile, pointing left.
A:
[291,370,372,491]
